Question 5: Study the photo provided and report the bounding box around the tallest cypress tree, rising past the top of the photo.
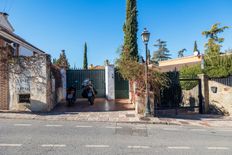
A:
[123,0,139,61]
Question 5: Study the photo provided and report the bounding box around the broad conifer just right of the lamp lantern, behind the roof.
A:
[152,39,171,64]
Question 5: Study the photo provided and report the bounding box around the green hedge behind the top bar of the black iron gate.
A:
[180,65,202,90]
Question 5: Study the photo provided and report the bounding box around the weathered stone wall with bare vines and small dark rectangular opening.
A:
[9,55,55,111]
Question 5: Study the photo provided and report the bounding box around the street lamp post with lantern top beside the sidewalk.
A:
[142,28,151,117]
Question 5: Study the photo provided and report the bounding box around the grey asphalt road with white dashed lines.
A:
[0,119,232,155]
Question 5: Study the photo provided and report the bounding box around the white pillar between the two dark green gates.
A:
[105,65,115,100]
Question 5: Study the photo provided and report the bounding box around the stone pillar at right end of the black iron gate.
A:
[198,74,209,114]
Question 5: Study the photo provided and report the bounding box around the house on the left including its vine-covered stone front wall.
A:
[0,13,64,111]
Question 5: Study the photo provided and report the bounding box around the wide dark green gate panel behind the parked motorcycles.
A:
[66,70,105,98]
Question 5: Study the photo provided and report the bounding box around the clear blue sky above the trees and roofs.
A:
[0,0,232,67]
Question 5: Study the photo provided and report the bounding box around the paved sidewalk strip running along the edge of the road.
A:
[0,110,232,128]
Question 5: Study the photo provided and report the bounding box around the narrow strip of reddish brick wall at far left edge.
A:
[0,39,9,110]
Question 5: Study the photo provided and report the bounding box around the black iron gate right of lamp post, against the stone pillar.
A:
[157,72,202,113]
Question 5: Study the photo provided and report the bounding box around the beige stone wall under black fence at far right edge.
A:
[209,80,232,115]
